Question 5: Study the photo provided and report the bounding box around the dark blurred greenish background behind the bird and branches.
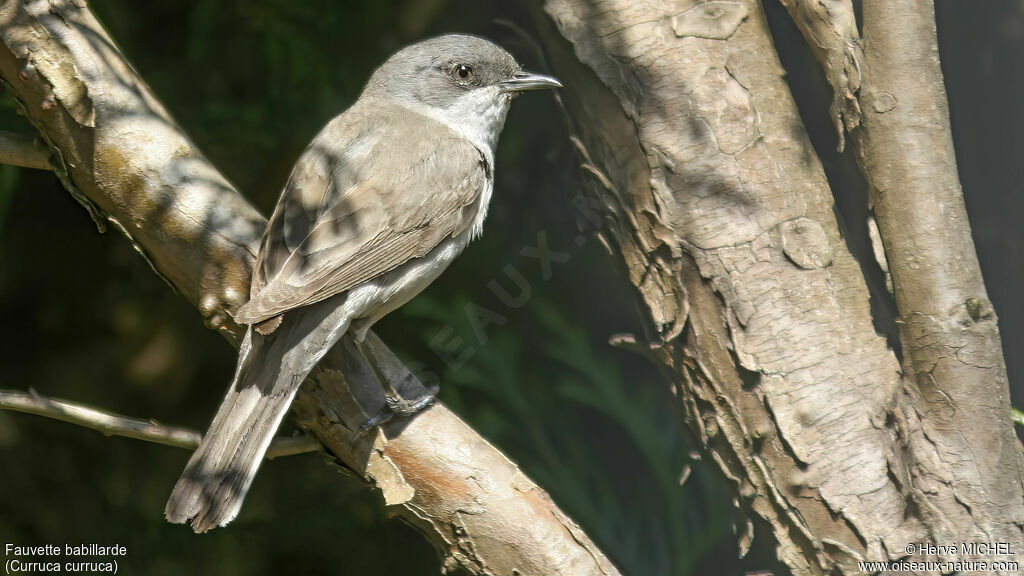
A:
[0,0,1024,575]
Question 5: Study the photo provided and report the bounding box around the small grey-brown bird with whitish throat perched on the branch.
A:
[165,34,561,532]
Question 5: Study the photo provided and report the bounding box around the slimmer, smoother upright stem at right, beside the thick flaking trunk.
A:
[783,0,1024,557]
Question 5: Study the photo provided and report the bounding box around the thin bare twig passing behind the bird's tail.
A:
[0,390,322,459]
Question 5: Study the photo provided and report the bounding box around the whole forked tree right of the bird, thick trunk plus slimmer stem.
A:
[538,0,1024,575]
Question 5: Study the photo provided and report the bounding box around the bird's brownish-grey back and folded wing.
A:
[236,103,490,324]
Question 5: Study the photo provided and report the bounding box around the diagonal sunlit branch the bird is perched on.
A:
[0,0,617,575]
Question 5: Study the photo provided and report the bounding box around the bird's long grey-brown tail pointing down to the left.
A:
[164,298,349,532]
